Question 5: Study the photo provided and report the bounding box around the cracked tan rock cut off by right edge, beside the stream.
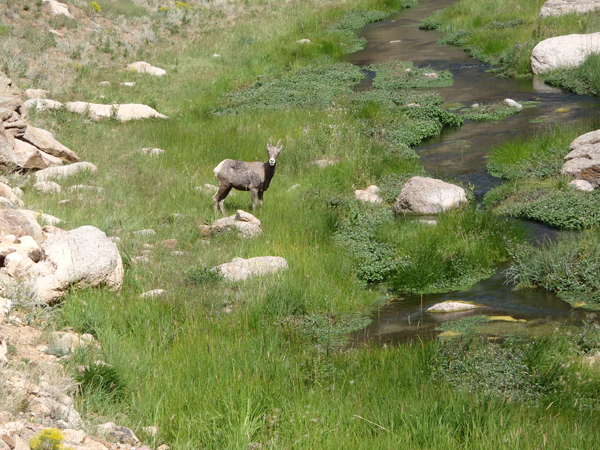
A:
[562,130,600,191]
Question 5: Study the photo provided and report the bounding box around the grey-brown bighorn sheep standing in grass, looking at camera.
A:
[213,139,283,215]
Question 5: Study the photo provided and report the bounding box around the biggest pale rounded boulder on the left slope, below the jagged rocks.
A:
[32,226,123,304]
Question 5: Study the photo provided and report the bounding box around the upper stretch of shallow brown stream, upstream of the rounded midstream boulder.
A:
[349,0,600,194]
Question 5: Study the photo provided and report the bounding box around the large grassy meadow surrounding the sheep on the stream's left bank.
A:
[3,0,600,450]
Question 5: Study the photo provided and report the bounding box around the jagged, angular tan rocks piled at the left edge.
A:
[0,72,81,171]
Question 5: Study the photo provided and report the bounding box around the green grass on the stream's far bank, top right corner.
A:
[420,0,600,76]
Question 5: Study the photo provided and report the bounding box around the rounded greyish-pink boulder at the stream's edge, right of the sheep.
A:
[394,177,467,214]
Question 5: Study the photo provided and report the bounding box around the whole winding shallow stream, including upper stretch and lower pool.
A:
[349,0,600,344]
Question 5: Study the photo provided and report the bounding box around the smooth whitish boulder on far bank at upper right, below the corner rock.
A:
[531,33,600,74]
